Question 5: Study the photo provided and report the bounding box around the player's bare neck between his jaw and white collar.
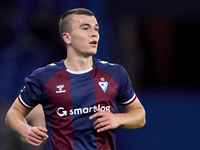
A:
[64,56,93,71]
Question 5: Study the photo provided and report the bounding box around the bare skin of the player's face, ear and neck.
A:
[63,15,99,71]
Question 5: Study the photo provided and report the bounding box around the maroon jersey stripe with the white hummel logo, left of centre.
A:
[45,70,74,150]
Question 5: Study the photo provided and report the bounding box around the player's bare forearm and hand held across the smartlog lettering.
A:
[90,98,146,132]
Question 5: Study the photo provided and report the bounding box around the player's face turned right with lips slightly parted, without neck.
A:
[63,15,99,57]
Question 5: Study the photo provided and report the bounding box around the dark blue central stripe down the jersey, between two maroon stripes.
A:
[70,71,97,150]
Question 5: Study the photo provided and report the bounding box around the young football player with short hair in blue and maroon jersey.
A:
[6,8,145,150]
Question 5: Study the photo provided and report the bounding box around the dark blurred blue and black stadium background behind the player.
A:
[0,0,200,150]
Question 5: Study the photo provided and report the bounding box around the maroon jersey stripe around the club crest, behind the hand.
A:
[92,68,117,150]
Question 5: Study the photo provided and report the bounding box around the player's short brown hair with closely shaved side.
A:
[59,8,94,43]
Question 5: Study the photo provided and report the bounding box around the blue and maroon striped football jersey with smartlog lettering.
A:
[18,58,136,150]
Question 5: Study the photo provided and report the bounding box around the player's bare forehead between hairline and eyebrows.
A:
[72,15,98,26]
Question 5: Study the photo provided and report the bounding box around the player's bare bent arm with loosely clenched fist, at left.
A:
[5,98,48,146]
